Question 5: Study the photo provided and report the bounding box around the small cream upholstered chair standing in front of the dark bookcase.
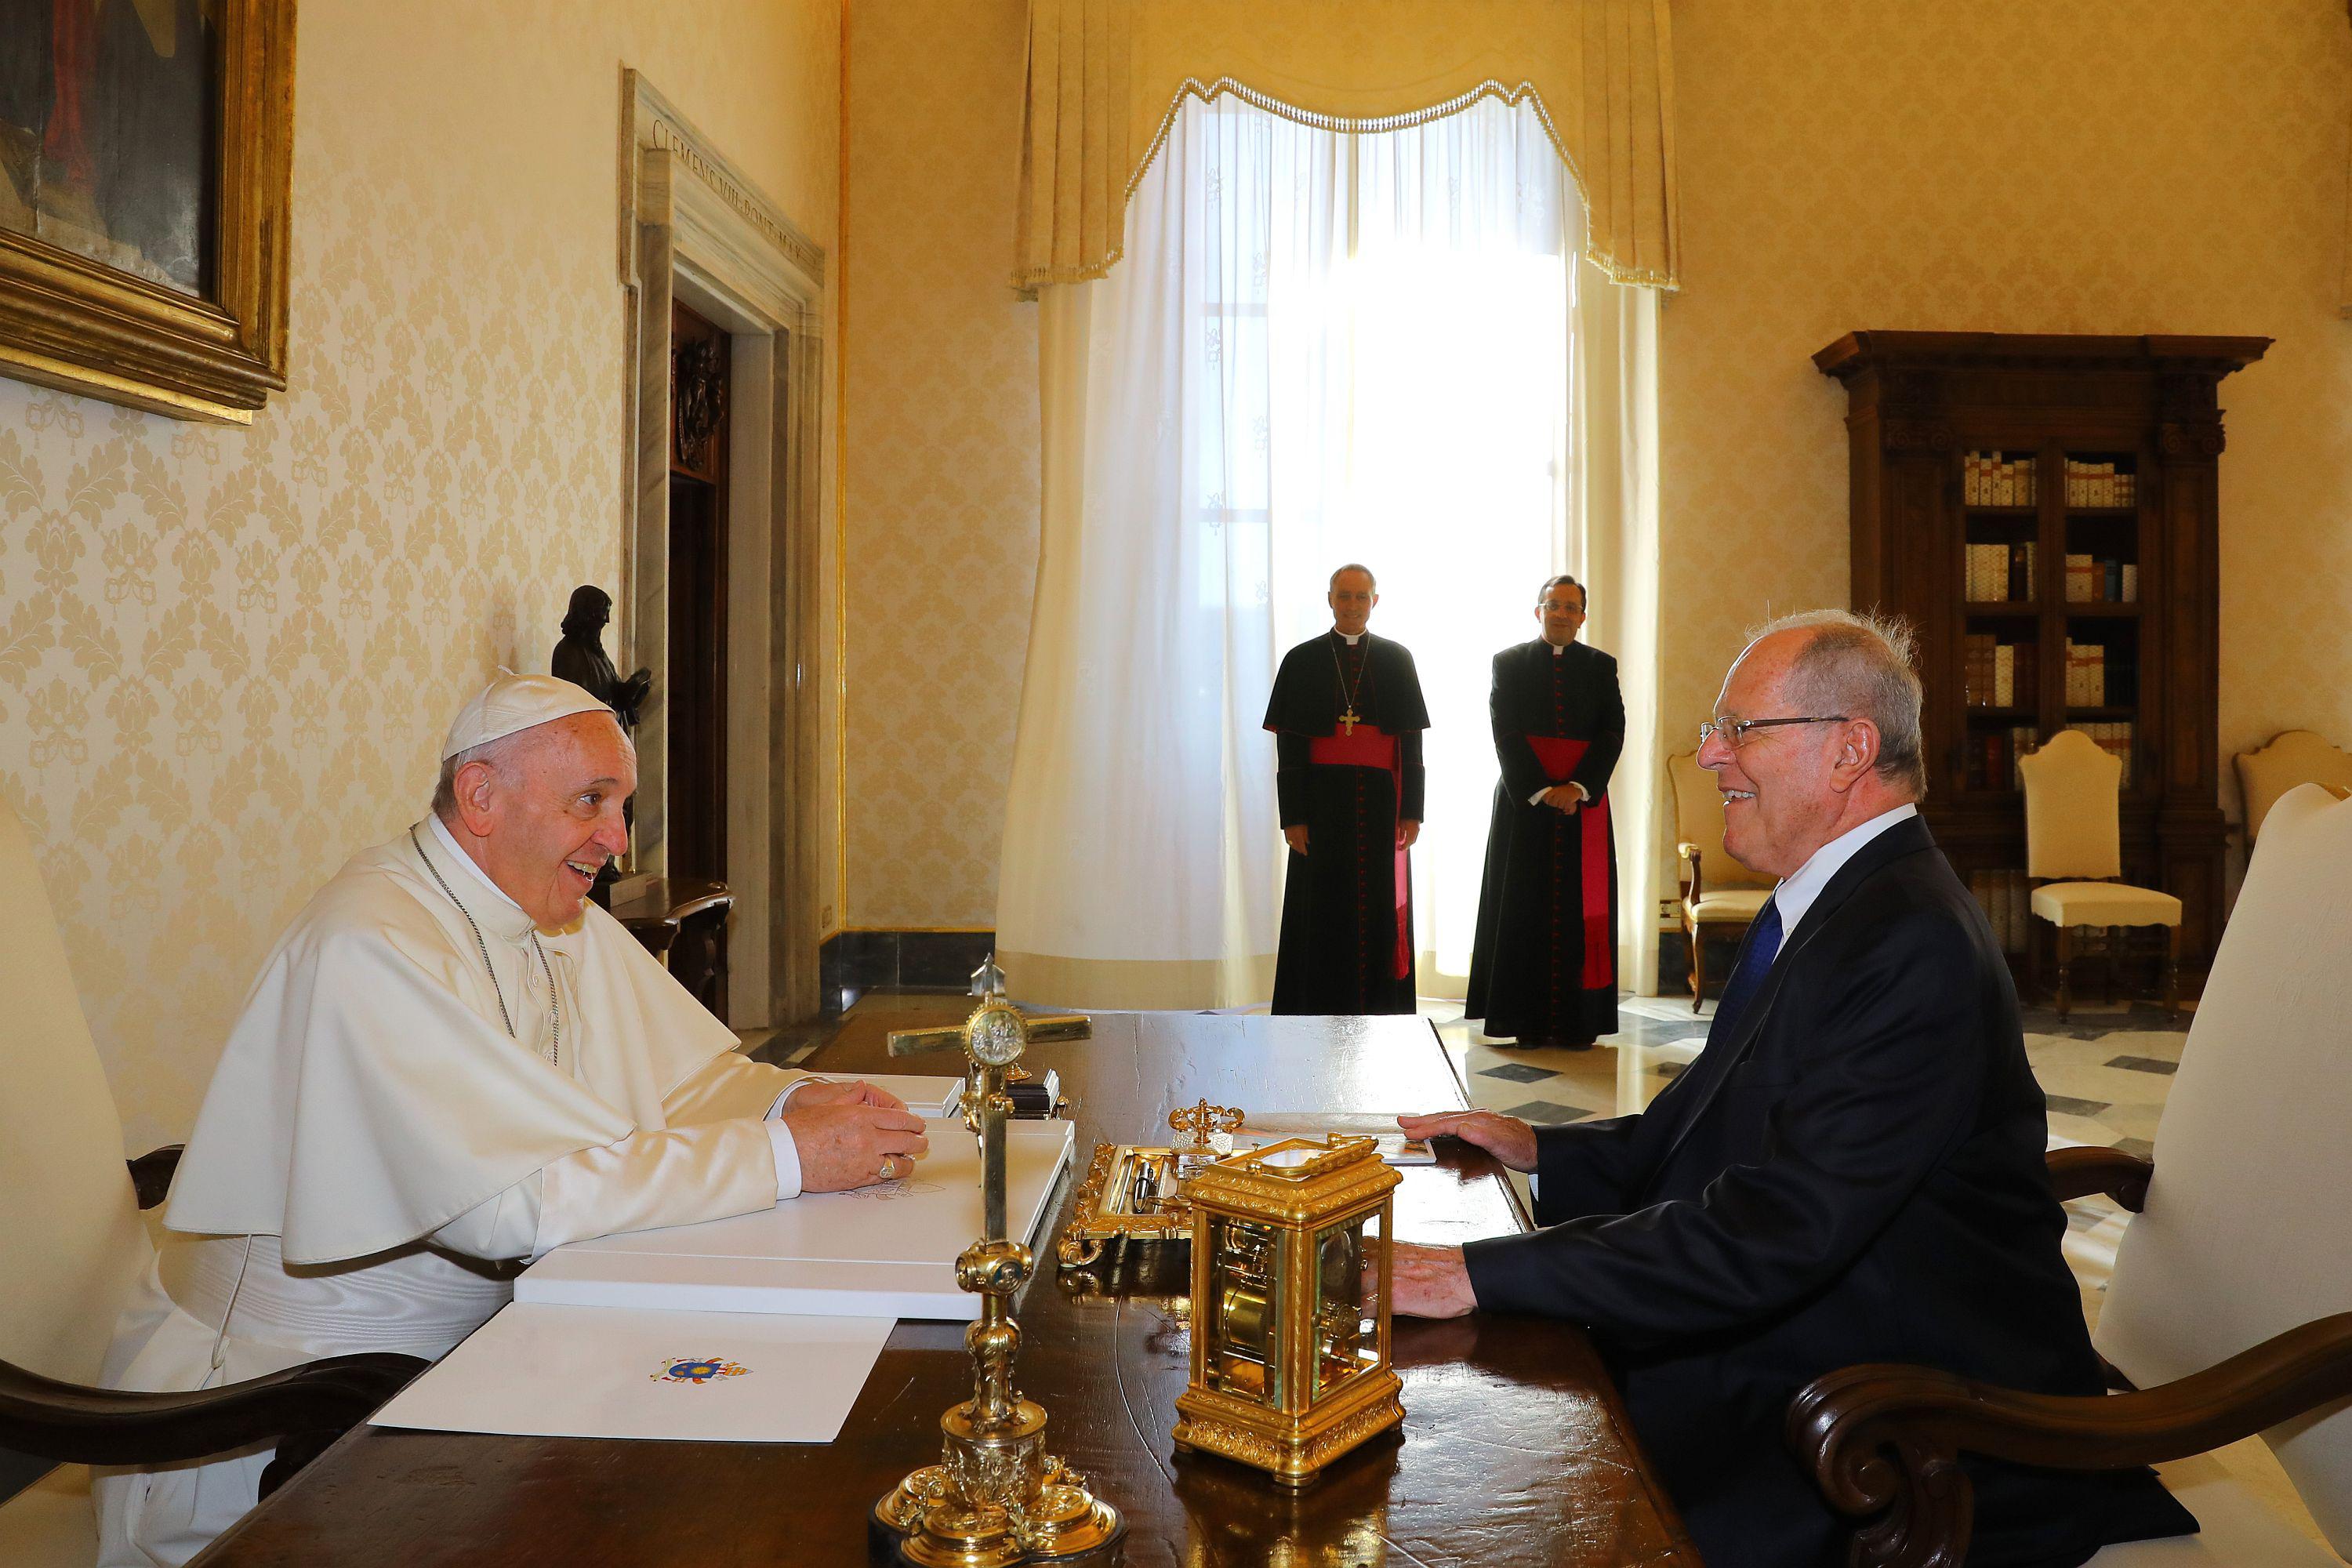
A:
[2018,729,2180,1018]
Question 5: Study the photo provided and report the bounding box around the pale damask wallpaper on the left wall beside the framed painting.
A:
[0,0,840,1149]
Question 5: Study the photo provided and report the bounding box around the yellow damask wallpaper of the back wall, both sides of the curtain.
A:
[847,0,2352,926]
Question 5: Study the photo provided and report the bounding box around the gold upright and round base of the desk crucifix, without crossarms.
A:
[873,994,1127,1568]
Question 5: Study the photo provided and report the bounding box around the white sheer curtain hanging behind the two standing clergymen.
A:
[997,96,1653,1006]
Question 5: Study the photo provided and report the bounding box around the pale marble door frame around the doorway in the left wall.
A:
[619,68,826,1029]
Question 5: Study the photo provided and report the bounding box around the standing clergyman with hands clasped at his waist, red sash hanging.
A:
[1463,576,1625,1046]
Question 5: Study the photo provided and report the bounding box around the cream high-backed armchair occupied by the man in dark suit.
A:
[1788,787,2352,1568]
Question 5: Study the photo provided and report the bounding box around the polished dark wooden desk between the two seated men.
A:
[183,1013,1698,1568]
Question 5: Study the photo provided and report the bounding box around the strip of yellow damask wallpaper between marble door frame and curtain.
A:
[842,0,1037,928]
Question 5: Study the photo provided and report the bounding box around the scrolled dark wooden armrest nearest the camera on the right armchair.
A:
[1788,1312,2352,1568]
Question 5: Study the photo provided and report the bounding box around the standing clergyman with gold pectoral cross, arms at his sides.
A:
[1265,569,1430,1013]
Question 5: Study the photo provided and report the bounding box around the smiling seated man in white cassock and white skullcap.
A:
[94,675,927,1568]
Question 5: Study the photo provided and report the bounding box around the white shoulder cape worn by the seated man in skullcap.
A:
[165,834,736,1265]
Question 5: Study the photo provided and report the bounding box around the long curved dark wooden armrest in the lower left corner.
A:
[0,1354,428,1465]
